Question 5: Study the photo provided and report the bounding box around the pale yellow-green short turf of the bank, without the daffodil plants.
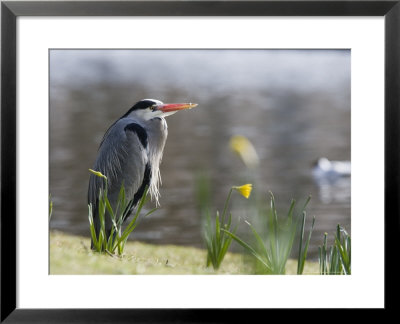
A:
[50,231,318,275]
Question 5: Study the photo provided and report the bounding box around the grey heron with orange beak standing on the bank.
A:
[88,99,197,247]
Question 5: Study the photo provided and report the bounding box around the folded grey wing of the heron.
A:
[88,118,151,220]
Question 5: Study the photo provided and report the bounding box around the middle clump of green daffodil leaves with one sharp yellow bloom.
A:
[196,168,324,275]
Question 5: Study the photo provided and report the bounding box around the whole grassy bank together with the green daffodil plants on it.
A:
[49,175,351,275]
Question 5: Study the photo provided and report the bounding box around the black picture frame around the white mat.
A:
[0,0,400,323]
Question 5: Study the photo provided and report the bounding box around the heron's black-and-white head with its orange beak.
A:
[122,99,197,120]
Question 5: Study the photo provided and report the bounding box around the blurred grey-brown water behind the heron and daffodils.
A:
[49,50,351,258]
